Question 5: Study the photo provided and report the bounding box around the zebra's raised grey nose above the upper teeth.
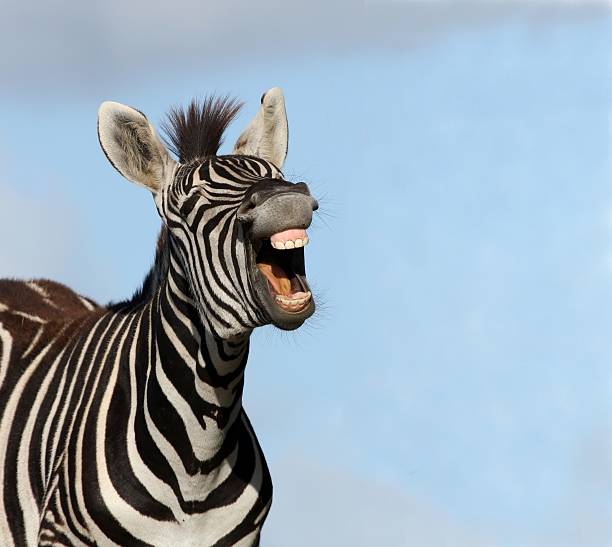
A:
[237,183,319,239]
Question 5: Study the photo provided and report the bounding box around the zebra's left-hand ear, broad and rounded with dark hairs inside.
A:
[98,101,175,193]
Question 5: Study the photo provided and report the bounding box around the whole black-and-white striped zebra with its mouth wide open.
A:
[0,88,317,547]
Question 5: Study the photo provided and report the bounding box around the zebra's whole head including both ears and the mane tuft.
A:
[98,88,317,338]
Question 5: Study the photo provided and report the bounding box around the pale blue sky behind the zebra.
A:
[0,0,612,547]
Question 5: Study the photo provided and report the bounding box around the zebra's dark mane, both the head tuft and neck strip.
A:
[107,96,242,311]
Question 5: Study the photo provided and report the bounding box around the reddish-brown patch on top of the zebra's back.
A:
[0,279,101,322]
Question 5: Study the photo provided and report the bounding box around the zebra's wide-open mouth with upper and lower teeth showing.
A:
[256,229,314,328]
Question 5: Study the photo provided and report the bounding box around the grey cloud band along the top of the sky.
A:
[0,0,609,96]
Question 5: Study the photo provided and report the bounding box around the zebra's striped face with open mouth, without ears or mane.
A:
[156,155,317,337]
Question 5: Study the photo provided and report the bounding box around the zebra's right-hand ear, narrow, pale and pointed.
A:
[233,87,289,169]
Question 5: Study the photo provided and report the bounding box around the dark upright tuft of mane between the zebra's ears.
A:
[161,95,242,163]
